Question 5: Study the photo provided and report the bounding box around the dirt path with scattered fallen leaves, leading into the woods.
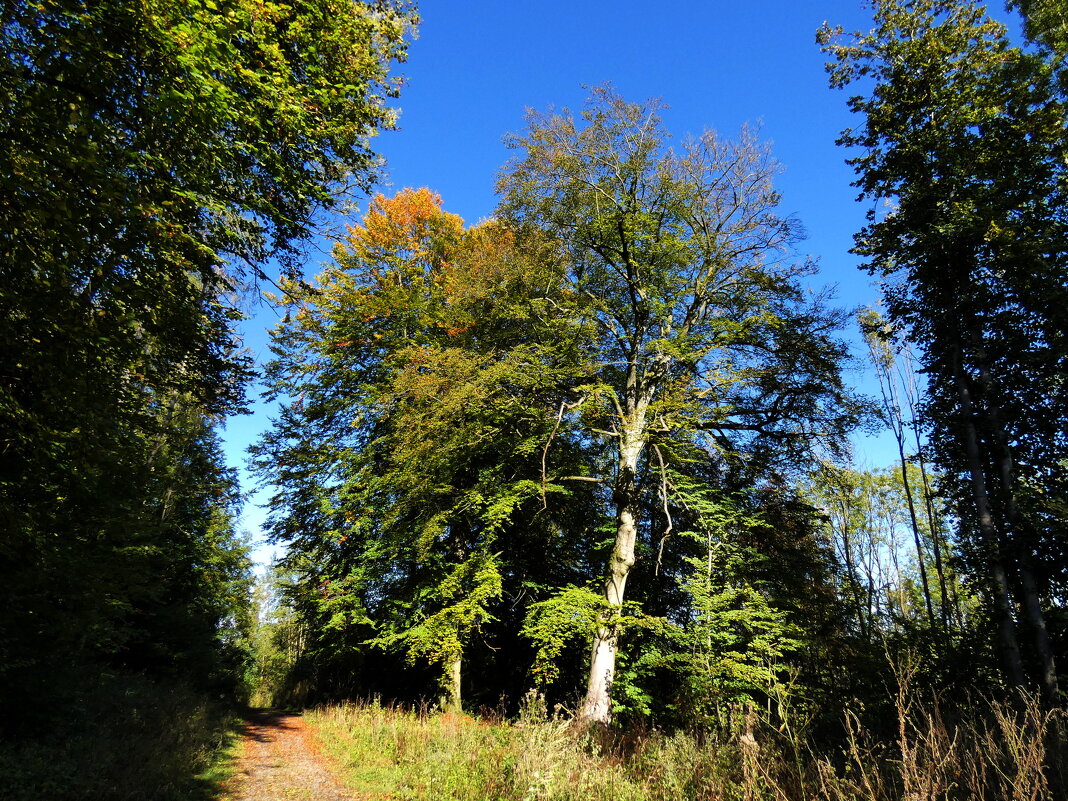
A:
[221,712,361,801]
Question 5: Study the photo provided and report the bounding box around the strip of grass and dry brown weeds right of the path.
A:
[308,694,1066,801]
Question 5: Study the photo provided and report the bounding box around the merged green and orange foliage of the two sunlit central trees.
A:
[256,95,855,726]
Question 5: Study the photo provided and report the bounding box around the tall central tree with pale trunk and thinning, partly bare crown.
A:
[499,89,843,723]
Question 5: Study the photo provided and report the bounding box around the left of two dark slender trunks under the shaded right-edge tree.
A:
[953,346,1025,689]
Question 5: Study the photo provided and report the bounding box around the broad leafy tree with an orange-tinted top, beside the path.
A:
[258,189,582,707]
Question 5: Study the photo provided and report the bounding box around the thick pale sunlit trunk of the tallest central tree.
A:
[578,416,646,725]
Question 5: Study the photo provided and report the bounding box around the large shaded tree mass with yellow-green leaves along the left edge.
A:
[0,0,410,717]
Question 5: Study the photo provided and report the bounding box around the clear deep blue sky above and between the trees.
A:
[224,0,914,559]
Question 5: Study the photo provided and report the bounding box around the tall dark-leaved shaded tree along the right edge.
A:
[820,0,1068,698]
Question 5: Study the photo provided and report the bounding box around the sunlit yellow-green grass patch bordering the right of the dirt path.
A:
[307,704,740,801]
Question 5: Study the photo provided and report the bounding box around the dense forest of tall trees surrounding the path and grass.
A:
[0,0,1068,799]
